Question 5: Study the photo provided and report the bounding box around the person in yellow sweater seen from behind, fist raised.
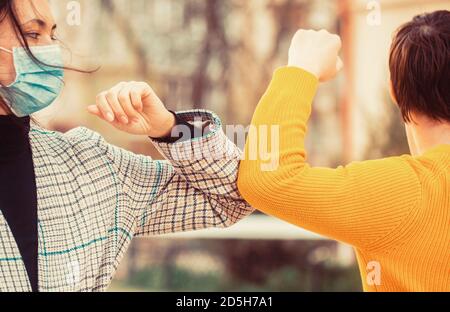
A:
[238,11,450,292]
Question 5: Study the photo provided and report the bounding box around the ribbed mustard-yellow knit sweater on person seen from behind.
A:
[238,67,450,291]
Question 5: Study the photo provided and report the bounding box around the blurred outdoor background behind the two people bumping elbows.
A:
[38,0,450,291]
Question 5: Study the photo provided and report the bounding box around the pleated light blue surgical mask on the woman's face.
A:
[0,45,64,117]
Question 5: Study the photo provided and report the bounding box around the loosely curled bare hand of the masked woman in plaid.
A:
[88,81,176,138]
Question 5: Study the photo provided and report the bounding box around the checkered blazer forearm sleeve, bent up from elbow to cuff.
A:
[137,110,253,235]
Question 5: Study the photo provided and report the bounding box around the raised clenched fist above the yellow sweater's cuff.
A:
[289,29,343,82]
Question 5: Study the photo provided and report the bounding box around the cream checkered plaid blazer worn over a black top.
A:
[0,111,253,291]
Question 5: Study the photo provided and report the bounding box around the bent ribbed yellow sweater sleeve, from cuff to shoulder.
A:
[238,67,421,248]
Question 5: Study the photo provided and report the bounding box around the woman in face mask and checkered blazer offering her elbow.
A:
[0,0,252,291]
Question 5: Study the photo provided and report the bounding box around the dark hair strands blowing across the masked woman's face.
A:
[0,0,98,122]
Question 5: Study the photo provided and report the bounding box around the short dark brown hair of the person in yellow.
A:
[389,10,450,122]
